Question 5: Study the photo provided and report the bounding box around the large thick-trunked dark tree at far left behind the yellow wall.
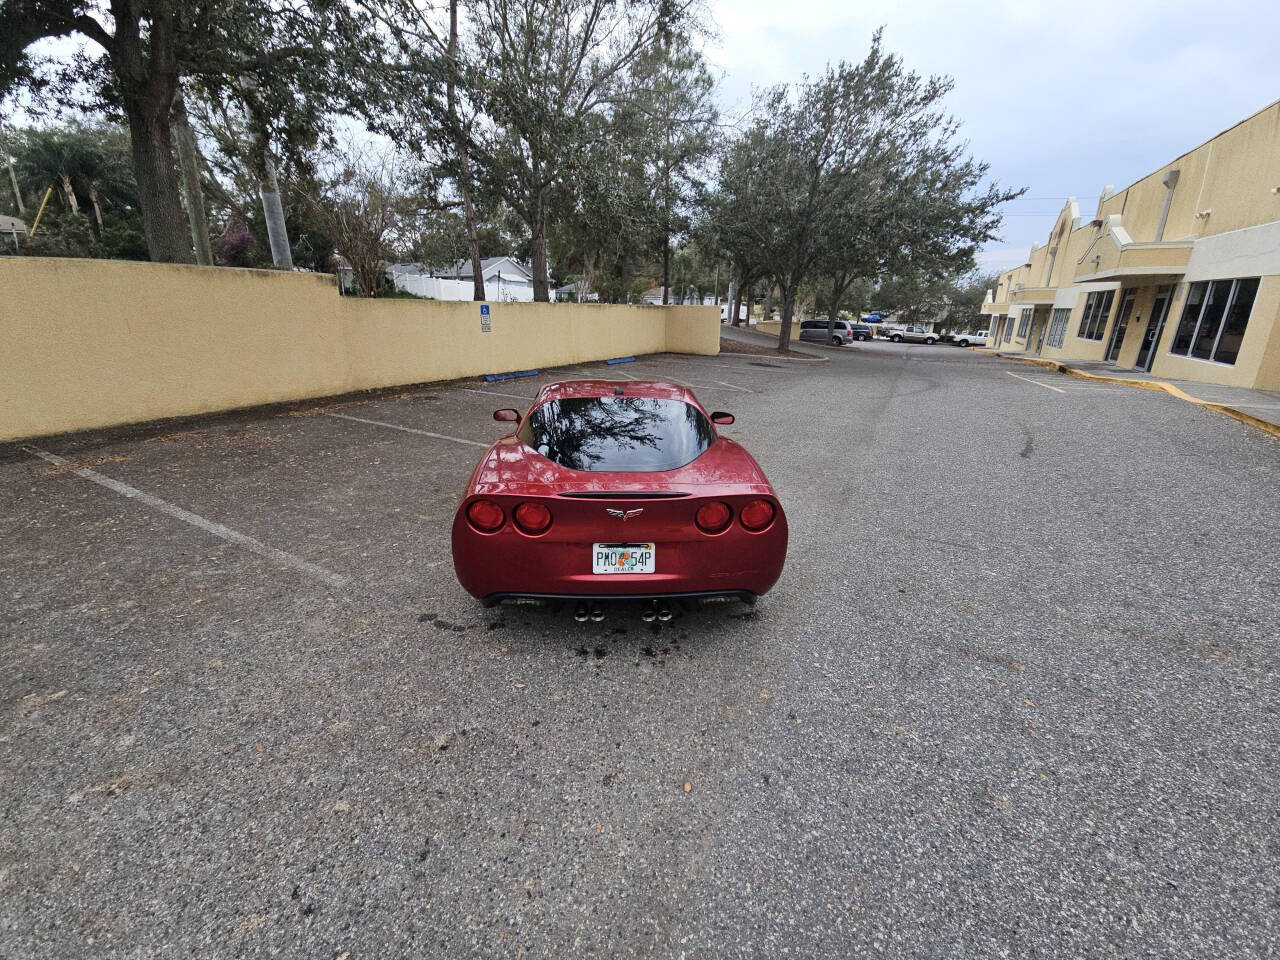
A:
[0,0,381,261]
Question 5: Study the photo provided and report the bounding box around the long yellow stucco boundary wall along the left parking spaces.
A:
[0,257,719,440]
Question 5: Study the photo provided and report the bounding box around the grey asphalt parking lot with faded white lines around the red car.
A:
[0,343,1280,960]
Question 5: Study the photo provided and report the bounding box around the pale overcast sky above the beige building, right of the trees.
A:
[708,0,1280,269]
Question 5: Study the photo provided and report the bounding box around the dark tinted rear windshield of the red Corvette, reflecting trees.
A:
[517,397,716,472]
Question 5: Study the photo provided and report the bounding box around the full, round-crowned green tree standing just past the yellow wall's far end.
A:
[712,33,1020,349]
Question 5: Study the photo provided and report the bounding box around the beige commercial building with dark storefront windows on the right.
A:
[982,102,1280,390]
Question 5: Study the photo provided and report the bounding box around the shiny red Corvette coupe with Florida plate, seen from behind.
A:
[453,380,787,620]
